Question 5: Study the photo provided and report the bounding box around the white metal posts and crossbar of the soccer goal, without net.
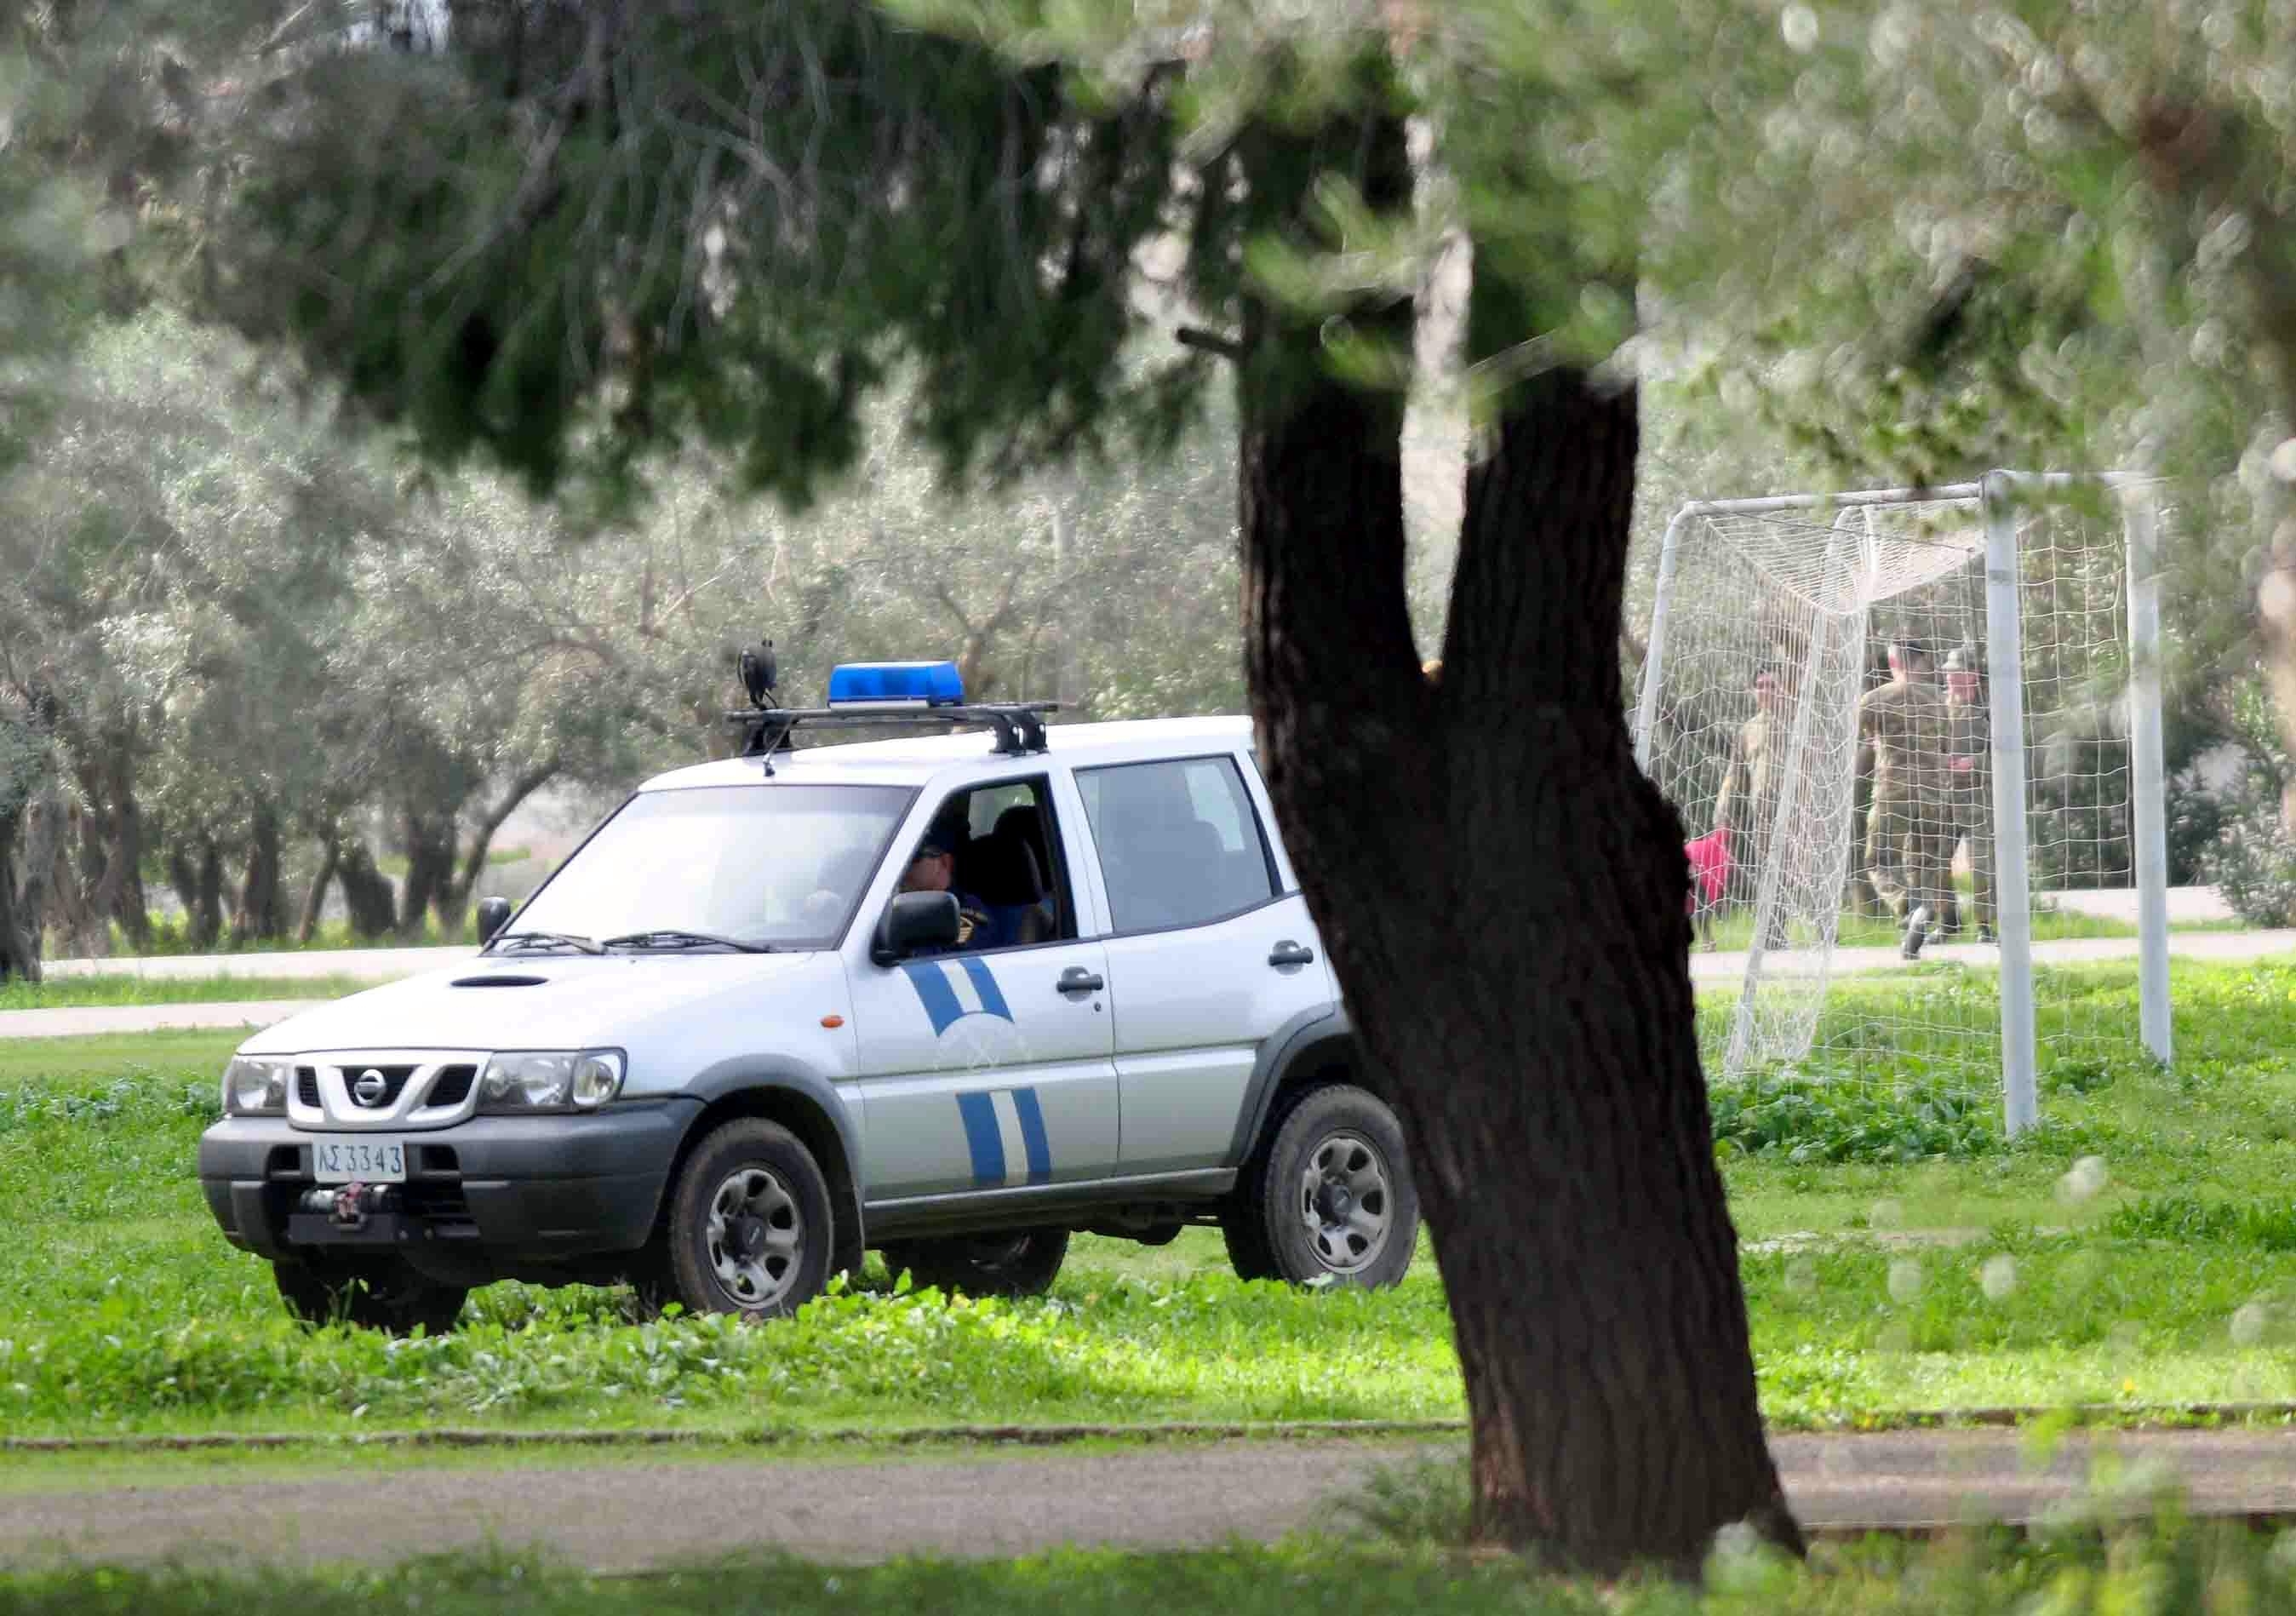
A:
[1635,471,2170,1134]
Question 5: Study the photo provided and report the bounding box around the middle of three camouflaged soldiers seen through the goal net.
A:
[1858,638,1951,960]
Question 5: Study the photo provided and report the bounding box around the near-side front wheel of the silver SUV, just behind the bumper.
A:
[666,1120,836,1320]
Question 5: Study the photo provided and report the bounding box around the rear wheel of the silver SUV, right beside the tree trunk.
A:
[1222,1084,1419,1290]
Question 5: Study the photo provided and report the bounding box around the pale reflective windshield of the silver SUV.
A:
[509,785,913,948]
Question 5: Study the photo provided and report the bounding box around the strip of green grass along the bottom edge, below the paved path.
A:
[0,1515,2296,1616]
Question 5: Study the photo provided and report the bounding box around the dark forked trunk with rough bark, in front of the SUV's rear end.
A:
[1240,107,1800,1573]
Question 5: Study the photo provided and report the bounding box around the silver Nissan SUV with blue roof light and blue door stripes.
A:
[200,663,1419,1332]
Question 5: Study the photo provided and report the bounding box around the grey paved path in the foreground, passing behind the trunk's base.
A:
[0,1430,2296,1570]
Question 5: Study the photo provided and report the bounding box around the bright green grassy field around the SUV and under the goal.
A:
[0,964,2296,1435]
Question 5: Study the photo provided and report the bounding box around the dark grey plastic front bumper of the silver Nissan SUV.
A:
[200,1099,701,1274]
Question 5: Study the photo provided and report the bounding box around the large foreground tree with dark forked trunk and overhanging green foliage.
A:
[134,0,2296,1567]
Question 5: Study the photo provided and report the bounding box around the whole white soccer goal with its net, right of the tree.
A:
[1635,471,2170,1134]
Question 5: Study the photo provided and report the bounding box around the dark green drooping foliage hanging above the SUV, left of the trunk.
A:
[211,0,1194,502]
